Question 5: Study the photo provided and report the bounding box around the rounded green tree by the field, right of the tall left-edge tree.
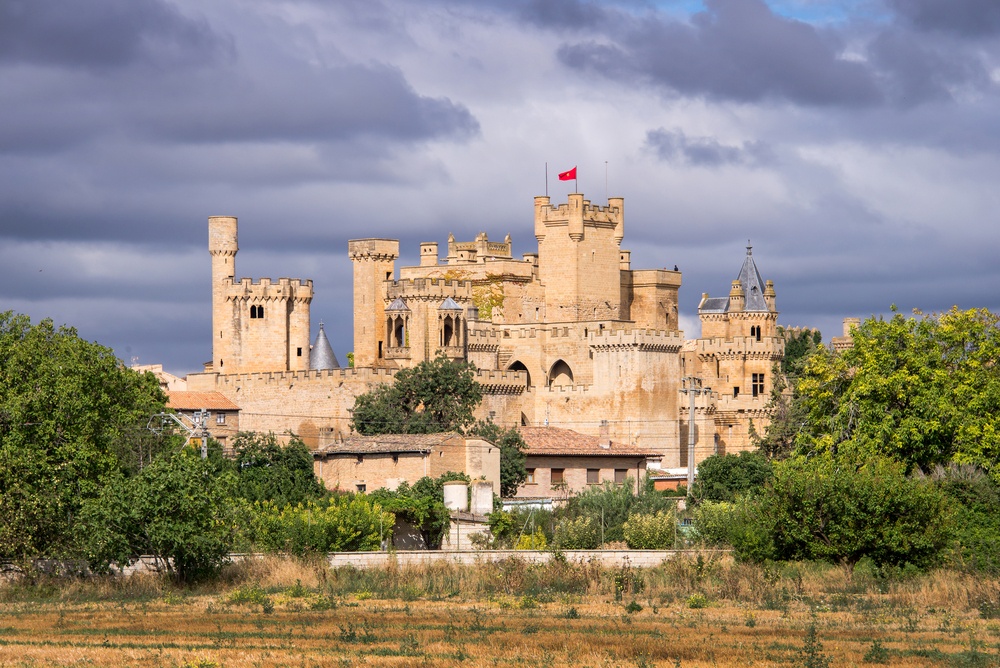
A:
[77,448,234,581]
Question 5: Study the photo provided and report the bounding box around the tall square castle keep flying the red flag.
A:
[535,193,625,322]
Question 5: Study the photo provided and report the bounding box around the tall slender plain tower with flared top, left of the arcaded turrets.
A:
[347,239,398,367]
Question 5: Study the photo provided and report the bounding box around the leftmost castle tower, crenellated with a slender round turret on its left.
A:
[208,216,312,374]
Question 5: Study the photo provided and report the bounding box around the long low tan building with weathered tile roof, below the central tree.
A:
[313,432,500,494]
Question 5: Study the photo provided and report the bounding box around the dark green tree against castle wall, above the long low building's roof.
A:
[351,355,483,435]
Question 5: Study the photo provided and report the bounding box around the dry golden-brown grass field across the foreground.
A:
[0,555,1000,668]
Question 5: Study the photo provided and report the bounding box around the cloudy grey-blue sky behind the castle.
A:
[0,0,1000,375]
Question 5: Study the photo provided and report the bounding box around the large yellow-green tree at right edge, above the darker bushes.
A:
[795,308,1000,479]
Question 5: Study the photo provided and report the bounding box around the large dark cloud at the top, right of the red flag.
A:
[559,0,881,107]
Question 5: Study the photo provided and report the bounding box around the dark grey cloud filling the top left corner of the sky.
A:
[0,0,228,70]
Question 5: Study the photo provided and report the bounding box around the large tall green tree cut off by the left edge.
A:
[0,311,165,560]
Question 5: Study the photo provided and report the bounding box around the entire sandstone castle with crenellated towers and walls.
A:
[188,193,784,467]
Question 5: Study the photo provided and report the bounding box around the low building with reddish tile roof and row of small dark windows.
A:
[516,427,662,499]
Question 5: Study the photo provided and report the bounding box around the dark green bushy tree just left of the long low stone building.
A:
[233,432,326,509]
